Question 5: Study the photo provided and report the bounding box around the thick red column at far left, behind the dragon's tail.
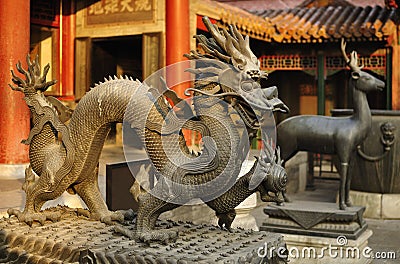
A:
[0,0,30,164]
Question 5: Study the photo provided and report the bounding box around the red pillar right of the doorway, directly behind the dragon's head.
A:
[166,0,191,97]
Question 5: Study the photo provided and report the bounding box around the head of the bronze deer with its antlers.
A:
[341,39,385,93]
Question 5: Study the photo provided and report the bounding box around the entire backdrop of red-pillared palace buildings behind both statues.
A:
[0,0,400,172]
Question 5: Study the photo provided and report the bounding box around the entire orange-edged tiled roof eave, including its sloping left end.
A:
[195,0,399,43]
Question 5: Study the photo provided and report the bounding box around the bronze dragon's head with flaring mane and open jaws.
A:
[185,17,289,129]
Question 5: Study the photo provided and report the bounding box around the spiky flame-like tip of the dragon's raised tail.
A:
[9,54,57,93]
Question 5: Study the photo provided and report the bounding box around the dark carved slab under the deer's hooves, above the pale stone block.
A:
[260,201,368,239]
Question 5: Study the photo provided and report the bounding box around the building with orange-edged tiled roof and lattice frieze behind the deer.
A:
[214,0,400,118]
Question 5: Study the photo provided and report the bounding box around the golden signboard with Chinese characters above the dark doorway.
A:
[86,0,154,25]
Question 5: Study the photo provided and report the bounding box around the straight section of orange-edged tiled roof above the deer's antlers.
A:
[255,5,398,43]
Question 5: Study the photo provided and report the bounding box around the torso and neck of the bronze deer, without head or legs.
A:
[278,87,371,160]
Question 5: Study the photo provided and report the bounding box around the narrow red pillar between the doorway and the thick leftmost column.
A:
[61,0,75,101]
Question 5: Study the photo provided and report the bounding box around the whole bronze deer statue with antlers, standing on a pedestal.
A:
[277,40,385,210]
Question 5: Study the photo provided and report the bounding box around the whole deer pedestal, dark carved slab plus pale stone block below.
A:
[260,201,372,264]
